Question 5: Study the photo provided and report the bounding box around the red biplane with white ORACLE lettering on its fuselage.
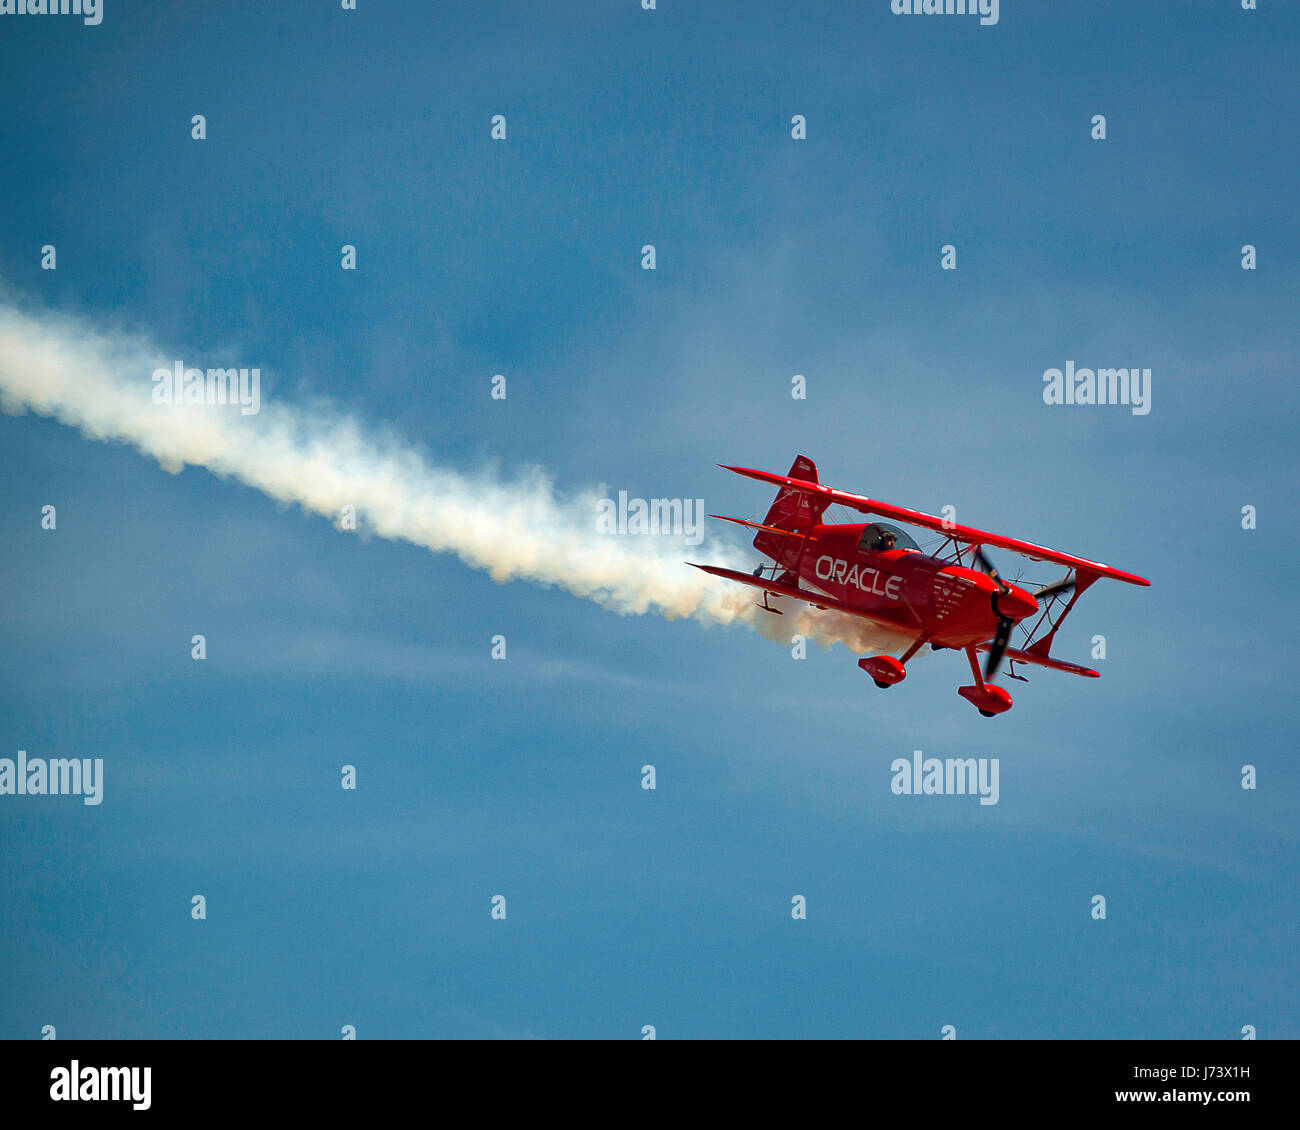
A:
[690,455,1151,718]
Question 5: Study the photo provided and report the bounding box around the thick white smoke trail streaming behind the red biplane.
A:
[0,300,906,651]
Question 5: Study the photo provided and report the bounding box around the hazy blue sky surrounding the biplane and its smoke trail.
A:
[0,0,1300,1039]
